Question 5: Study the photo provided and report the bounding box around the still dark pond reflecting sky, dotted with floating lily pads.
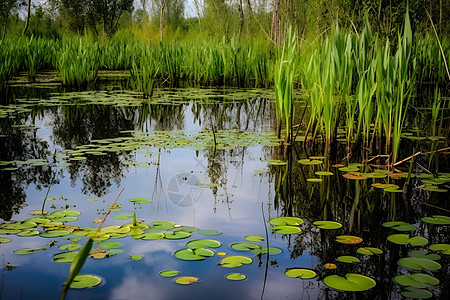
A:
[0,76,450,299]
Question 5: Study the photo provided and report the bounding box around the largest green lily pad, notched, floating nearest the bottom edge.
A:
[323,273,376,292]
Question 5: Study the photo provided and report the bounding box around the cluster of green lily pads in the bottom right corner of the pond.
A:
[382,215,450,299]
